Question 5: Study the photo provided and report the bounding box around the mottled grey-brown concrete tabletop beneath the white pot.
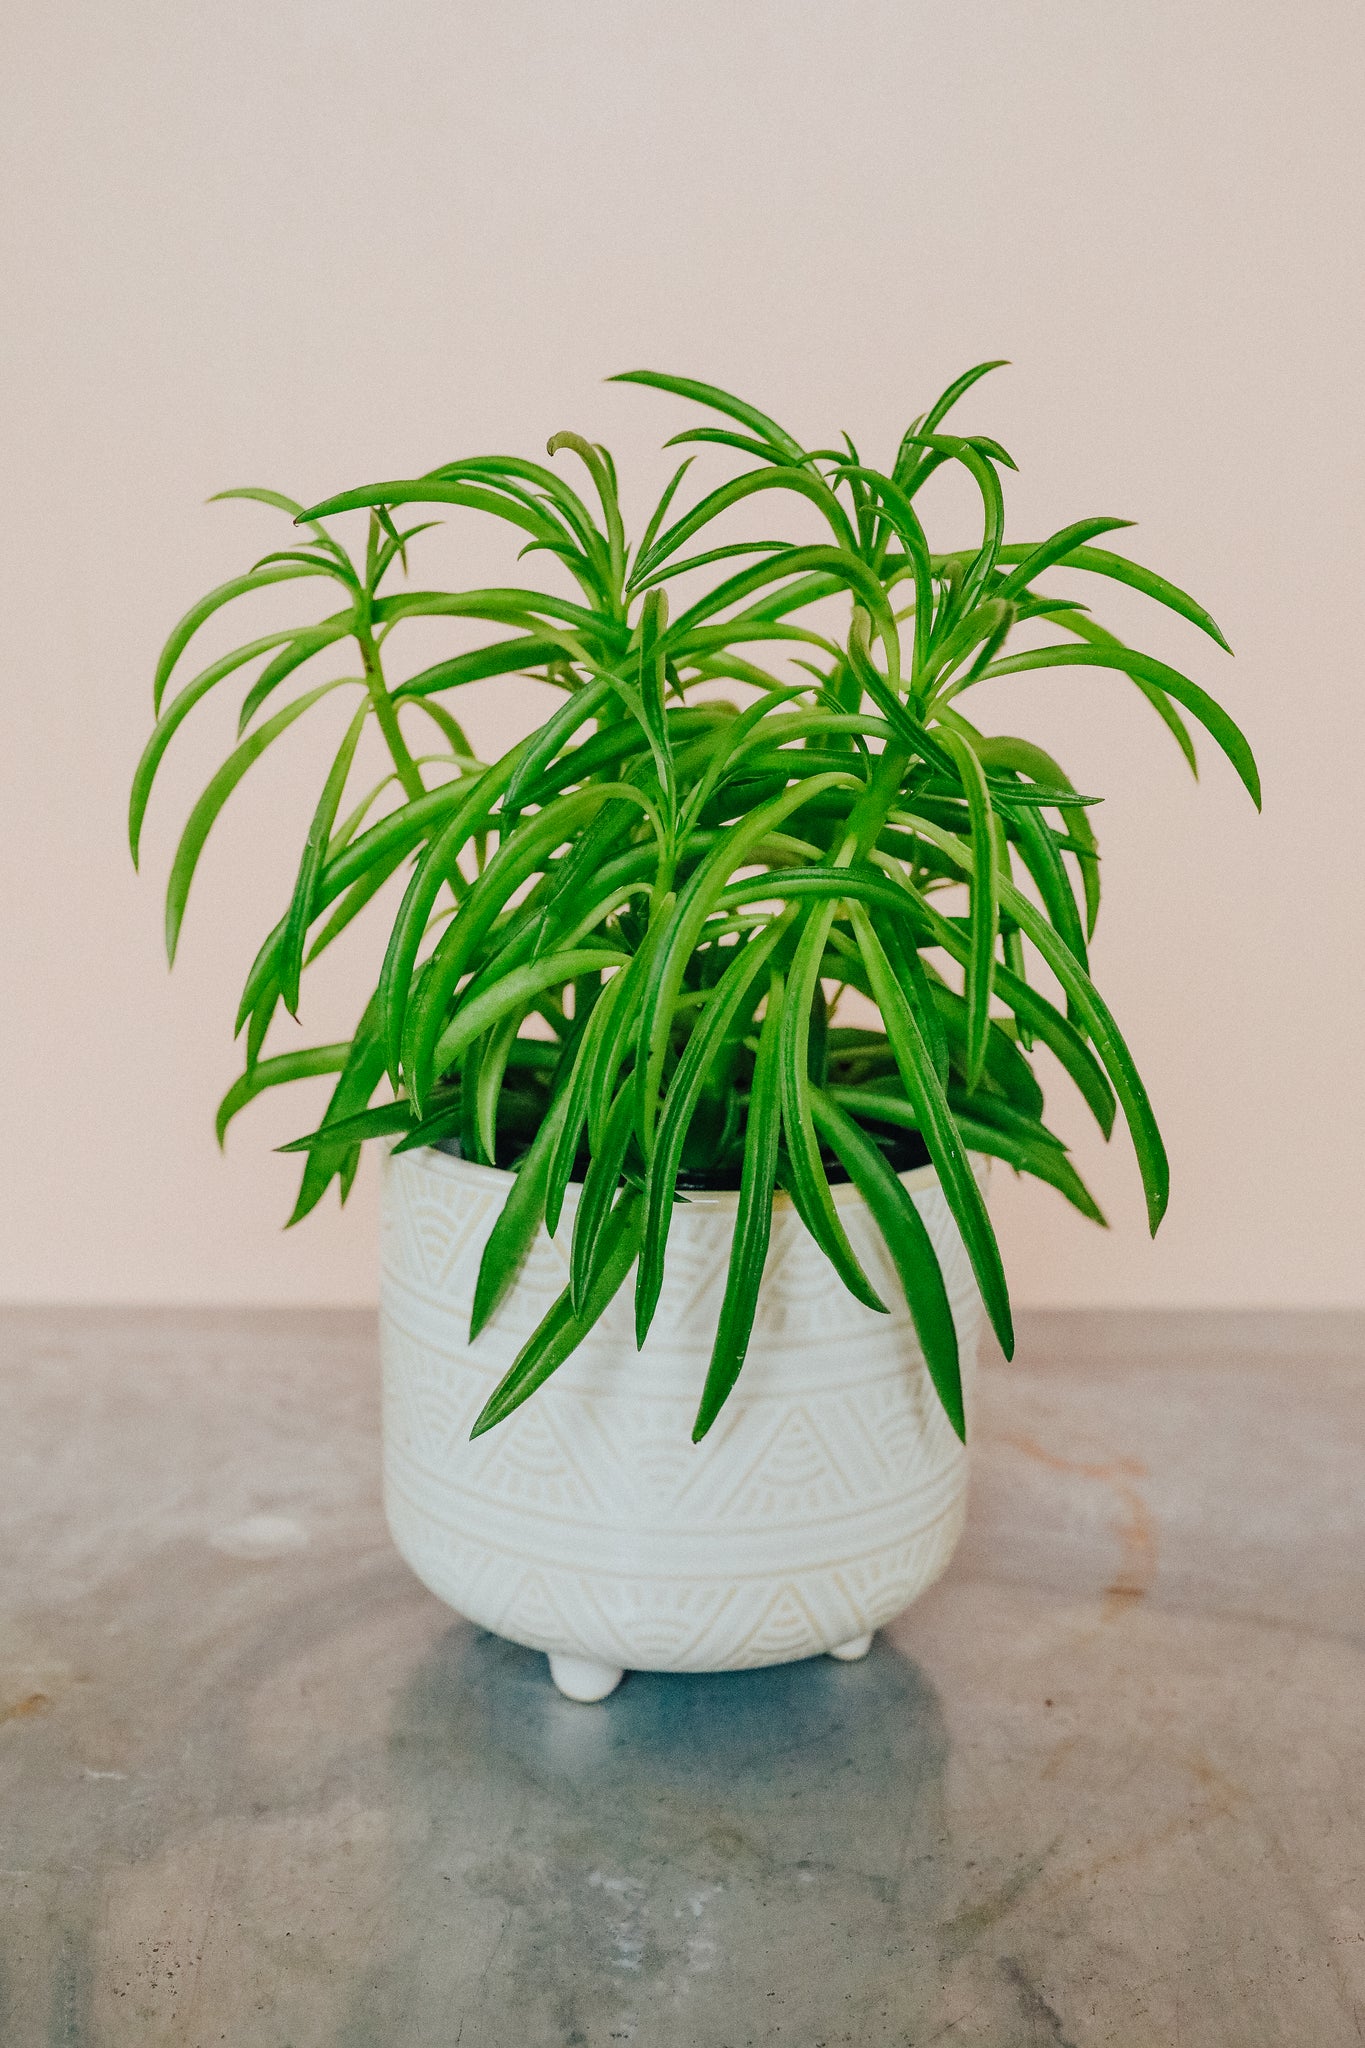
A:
[0,1311,1365,2048]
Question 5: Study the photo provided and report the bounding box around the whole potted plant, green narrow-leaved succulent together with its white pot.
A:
[131,362,1259,1698]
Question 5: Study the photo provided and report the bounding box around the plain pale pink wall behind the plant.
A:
[0,0,1365,1305]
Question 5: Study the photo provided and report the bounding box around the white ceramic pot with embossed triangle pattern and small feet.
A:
[381,1151,980,1700]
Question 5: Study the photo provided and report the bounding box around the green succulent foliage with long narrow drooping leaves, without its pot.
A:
[131,362,1259,1438]
